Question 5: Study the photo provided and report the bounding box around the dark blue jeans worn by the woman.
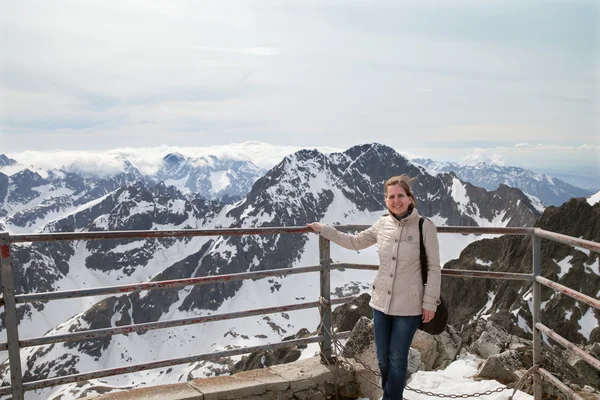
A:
[373,309,422,400]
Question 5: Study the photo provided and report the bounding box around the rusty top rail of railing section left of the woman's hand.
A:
[10,226,313,243]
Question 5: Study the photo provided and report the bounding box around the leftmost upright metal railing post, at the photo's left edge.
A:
[0,232,23,400]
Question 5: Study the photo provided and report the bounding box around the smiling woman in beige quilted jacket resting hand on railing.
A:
[307,175,441,400]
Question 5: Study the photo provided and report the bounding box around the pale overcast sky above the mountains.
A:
[0,0,600,172]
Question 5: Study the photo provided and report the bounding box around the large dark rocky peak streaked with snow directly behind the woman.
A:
[0,144,540,399]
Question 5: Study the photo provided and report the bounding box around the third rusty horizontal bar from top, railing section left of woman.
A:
[19,296,353,348]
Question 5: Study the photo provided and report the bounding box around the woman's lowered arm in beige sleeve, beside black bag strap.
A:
[423,219,442,311]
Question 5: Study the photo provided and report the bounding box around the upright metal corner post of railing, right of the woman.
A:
[531,233,542,400]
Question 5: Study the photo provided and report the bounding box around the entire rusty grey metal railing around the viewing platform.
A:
[0,225,600,400]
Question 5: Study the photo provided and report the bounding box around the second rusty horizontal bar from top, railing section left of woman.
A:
[15,265,323,304]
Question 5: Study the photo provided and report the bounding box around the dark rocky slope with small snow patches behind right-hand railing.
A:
[442,198,600,344]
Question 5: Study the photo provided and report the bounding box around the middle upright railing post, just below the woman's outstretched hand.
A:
[319,235,332,362]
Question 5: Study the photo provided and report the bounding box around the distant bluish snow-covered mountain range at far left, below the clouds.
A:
[0,154,264,232]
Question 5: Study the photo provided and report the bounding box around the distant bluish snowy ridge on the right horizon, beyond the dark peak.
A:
[412,158,591,206]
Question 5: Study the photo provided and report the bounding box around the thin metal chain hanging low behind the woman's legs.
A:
[319,297,540,400]
